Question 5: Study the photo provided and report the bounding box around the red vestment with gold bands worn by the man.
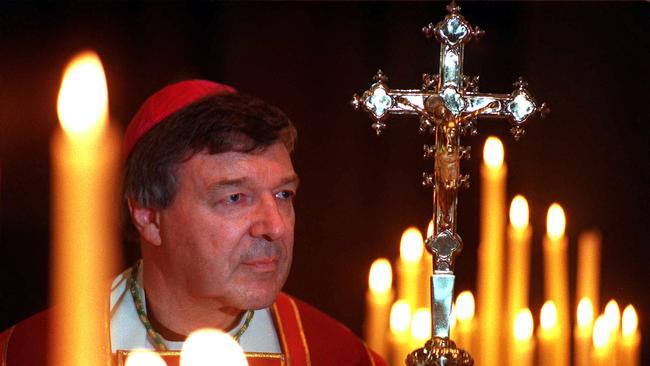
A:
[0,293,386,366]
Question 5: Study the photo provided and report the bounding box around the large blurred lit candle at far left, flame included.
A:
[49,52,120,366]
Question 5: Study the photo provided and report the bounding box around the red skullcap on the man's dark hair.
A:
[122,80,237,160]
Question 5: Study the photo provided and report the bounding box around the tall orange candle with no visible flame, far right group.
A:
[576,230,601,309]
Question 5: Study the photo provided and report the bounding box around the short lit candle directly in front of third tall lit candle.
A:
[537,300,566,366]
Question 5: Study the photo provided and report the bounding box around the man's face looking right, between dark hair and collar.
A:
[160,143,298,309]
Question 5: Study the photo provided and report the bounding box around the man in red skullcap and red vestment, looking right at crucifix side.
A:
[0,80,384,366]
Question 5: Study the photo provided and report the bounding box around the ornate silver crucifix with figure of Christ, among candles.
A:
[352,2,547,365]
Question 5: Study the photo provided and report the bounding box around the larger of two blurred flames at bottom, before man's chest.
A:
[180,328,248,366]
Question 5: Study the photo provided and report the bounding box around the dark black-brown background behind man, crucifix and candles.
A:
[0,2,650,362]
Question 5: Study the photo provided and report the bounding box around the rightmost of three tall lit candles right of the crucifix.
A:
[542,203,571,366]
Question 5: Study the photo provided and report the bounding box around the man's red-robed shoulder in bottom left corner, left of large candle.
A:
[0,309,55,366]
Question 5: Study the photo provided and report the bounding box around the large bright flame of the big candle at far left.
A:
[57,51,108,136]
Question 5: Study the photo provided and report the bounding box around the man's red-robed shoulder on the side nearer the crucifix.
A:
[276,293,385,366]
